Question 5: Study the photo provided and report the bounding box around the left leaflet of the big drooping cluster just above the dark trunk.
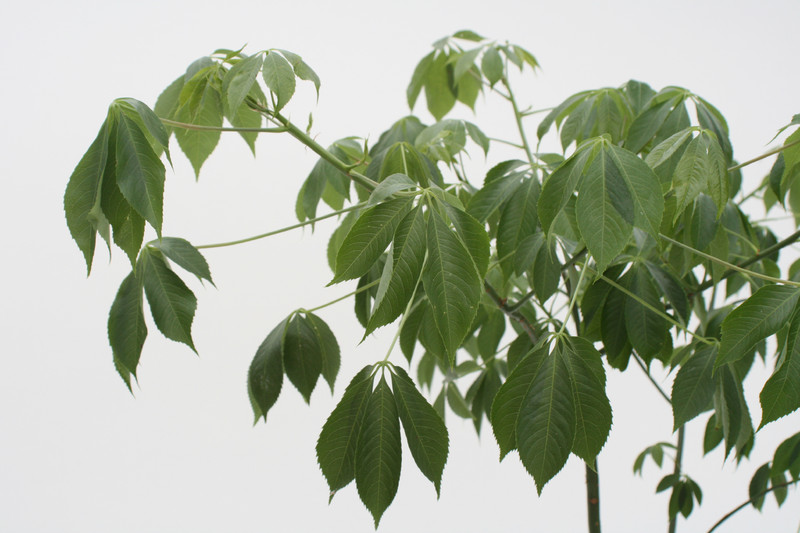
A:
[491,347,548,459]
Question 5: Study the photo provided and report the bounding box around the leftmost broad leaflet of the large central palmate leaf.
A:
[331,198,412,283]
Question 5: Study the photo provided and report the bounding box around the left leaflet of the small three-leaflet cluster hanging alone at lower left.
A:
[247,317,289,422]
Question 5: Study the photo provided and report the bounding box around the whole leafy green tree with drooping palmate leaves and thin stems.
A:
[64,31,800,531]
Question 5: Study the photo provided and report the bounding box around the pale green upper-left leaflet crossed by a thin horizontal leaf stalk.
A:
[175,76,223,177]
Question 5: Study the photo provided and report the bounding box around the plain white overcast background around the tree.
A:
[0,0,800,532]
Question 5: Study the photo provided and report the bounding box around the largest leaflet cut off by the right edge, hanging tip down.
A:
[759,313,800,429]
